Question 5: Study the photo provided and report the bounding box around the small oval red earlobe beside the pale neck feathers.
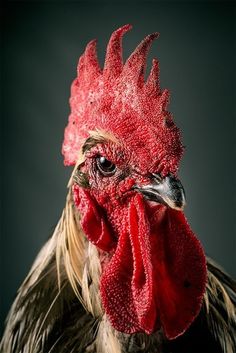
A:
[73,184,116,251]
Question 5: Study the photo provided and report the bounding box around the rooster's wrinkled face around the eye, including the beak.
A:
[76,135,185,216]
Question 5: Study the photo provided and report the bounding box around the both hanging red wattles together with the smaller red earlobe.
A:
[74,187,206,339]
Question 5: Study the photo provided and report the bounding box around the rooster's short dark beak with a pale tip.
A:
[135,174,186,210]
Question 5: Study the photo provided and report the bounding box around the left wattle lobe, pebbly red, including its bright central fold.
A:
[100,195,159,334]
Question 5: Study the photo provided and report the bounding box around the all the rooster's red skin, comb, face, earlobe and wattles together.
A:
[63,26,206,339]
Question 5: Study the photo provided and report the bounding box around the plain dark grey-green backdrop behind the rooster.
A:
[1,1,236,336]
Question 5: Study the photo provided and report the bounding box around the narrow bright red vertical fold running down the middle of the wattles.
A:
[129,195,157,333]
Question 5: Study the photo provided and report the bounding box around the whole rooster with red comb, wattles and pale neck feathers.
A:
[1,25,236,353]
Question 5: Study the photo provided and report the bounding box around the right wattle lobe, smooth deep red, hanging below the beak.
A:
[150,206,207,339]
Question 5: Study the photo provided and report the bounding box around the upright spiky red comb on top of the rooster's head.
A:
[62,25,182,173]
